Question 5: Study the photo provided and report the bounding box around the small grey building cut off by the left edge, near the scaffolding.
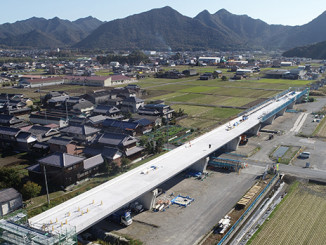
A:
[0,188,23,217]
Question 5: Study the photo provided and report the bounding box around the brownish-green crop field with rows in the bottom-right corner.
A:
[248,183,326,245]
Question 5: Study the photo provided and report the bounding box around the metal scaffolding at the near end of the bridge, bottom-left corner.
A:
[0,219,77,245]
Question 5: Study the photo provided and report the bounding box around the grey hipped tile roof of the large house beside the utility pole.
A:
[39,152,85,168]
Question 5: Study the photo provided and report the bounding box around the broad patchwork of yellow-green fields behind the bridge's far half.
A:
[138,72,312,130]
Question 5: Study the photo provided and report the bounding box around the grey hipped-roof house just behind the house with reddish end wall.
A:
[60,125,100,143]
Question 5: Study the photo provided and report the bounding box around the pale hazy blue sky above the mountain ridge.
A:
[0,0,326,25]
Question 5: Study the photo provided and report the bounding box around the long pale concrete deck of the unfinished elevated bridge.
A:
[29,89,306,233]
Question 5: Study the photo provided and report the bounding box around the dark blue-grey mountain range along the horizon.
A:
[0,7,326,50]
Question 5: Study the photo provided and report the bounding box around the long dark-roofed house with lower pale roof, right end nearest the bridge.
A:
[97,133,144,160]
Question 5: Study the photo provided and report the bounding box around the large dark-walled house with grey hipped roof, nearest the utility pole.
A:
[27,152,104,187]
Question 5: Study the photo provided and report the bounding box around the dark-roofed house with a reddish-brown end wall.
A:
[47,137,83,155]
